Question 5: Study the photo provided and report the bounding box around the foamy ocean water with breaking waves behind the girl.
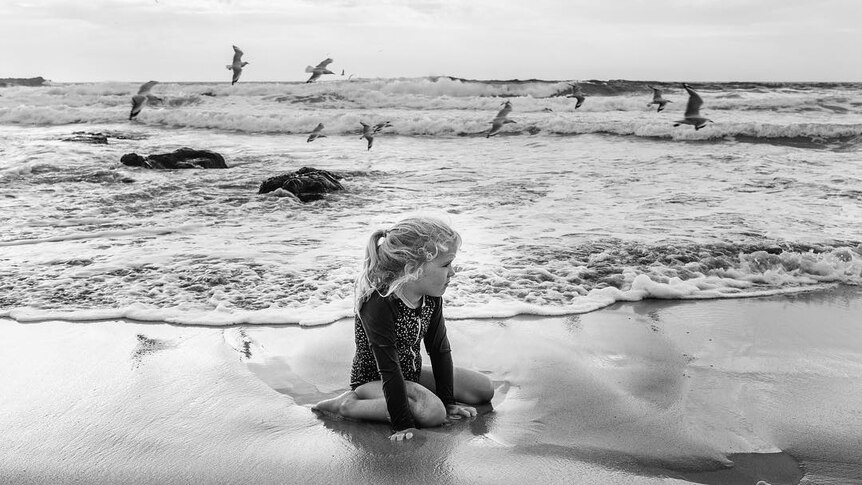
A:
[0,77,862,325]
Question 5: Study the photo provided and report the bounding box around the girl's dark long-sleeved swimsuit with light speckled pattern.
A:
[350,292,455,430]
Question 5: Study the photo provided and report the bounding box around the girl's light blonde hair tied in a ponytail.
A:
[355,217,461,312]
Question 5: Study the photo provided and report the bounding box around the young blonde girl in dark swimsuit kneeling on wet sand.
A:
[313,217,494,441]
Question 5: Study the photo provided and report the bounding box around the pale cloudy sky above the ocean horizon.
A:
[0,0,862,82]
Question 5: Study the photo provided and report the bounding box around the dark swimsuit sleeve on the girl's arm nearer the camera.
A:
[359,294,416,431]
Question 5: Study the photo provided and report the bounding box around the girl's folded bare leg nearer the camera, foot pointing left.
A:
[312,381,446,427]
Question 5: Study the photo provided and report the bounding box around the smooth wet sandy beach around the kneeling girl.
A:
[0,287,862,485]
